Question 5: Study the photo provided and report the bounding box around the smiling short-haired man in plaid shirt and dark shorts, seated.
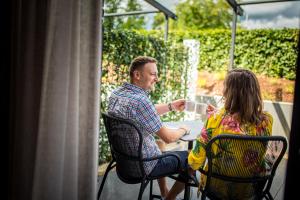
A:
[108,56,189,200]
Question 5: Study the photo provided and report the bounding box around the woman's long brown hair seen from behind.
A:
[223,69,263,124]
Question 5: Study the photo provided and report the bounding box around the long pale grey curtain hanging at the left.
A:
[9,0,102,200]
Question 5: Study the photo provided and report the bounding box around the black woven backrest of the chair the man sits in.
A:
[102,113,146,183]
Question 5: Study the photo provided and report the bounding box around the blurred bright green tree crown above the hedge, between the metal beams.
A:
[152,0,232,30]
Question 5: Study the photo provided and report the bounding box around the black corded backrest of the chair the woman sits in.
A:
[200,134,287,199]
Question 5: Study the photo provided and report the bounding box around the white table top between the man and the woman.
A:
[163,120,204,141]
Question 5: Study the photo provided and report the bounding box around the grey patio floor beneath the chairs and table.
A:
[98,143,287,200]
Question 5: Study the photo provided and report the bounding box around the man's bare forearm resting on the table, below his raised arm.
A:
[156,126,190,144]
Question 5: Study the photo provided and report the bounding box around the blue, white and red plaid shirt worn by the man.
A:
[108,83,162,174]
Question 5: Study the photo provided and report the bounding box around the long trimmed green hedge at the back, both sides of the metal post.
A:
[140,29,299,80]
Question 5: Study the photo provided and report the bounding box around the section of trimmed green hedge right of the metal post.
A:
[235,29,299,80]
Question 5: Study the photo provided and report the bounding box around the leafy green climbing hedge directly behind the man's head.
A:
[99,30,187,162]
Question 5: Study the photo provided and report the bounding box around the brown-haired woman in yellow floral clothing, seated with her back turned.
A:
[188,69,273,199]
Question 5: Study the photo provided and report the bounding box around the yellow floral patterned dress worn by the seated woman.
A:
[188,108,273,199]
